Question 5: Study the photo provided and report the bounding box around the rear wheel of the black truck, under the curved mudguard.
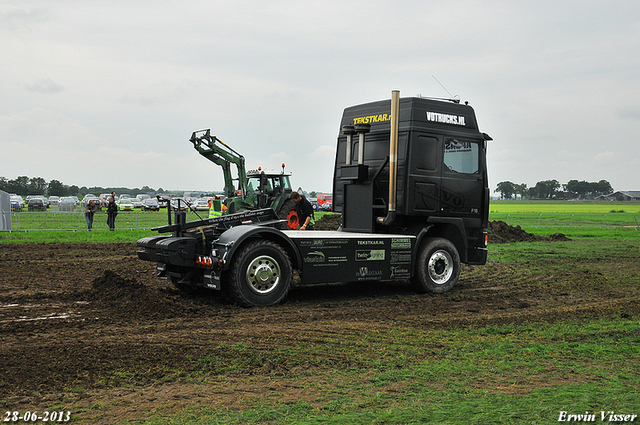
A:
[223,239,292,307]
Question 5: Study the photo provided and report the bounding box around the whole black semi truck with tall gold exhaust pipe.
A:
[137,91,491,307]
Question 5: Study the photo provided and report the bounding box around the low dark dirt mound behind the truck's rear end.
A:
[89,270,205,320]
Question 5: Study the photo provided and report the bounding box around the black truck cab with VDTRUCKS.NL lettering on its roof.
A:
[333,97,491,264]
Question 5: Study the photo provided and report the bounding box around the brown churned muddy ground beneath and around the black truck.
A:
[0,223,638,423]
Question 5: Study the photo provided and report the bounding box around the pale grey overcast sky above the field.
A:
[0,0,640,191]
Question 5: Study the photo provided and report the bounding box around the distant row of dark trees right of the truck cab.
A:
[496,180,613,199]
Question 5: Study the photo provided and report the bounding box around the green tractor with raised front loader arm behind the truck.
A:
[189,129,299,229]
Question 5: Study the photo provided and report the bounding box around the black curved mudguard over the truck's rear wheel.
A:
[214,224,302,270]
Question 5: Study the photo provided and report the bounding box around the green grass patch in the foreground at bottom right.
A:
[135,316,640,424]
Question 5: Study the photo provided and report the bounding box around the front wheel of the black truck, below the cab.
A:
[411,238,460,294]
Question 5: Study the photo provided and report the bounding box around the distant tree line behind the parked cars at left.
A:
[0,176,164,196]
